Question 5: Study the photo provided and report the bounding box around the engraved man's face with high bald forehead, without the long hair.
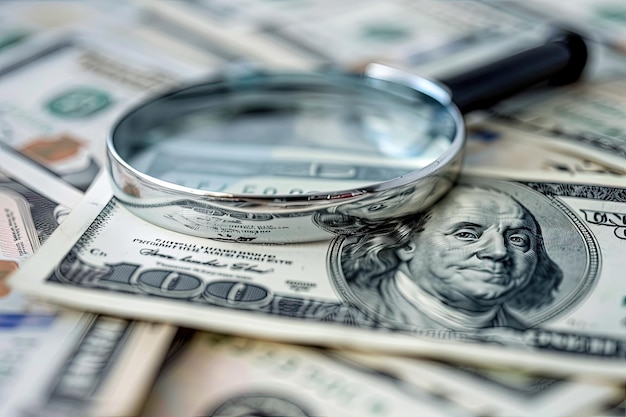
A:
[400,187,538,309]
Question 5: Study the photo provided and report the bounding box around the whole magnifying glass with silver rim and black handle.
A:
[107,32,587,243]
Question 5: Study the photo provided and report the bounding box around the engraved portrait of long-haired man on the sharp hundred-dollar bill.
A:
[326,178,596,331]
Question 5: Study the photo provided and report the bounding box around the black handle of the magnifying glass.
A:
[440,31,587,114]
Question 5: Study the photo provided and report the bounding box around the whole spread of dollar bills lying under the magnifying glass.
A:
[0,0,626,417]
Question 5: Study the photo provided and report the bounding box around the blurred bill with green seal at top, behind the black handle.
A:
[271,1,545,70]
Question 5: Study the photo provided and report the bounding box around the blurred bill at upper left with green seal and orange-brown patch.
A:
[0,32,210,190]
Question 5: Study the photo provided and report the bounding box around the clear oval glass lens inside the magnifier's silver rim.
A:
[115,74,459,195]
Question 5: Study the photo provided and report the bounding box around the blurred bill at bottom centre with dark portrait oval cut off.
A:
[141,333,470,417]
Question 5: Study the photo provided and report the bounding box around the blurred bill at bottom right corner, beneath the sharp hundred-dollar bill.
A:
[338,351,625,417]
